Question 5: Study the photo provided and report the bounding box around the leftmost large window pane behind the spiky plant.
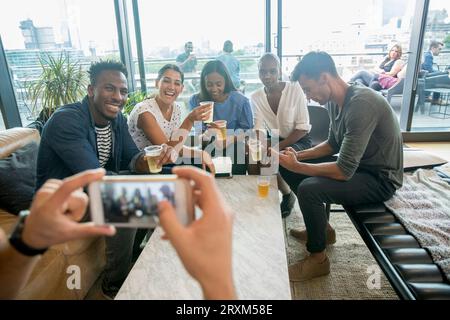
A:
[0,0,120,125]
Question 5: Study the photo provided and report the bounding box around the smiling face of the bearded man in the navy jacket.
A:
[88,70,128,125]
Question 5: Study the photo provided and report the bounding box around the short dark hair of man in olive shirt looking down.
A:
[291,51,338,81]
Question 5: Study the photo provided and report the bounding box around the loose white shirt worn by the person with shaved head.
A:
[251,82,311,139]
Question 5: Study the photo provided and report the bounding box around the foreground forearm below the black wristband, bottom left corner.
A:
[0,243,39,300]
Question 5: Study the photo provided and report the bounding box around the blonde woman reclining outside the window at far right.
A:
[350,44,403,89]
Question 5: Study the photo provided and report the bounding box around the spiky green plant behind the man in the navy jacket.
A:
[29,51,88,125]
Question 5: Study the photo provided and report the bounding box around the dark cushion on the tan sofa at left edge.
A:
[0,142,39,215]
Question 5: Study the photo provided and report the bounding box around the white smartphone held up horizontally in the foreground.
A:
[88,175,195,228]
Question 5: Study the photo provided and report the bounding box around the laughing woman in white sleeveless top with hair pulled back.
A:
[128,64,215,172]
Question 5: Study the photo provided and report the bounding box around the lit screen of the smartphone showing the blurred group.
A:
[100,181,176,226]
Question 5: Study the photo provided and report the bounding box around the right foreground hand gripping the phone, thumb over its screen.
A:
[161,166,236,299]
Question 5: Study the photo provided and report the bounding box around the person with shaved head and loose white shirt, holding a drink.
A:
[251,53,311,217]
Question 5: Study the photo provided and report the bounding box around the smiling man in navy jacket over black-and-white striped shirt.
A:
[37,61,173,296]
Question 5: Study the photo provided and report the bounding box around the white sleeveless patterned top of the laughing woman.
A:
[128,98,181,150]
